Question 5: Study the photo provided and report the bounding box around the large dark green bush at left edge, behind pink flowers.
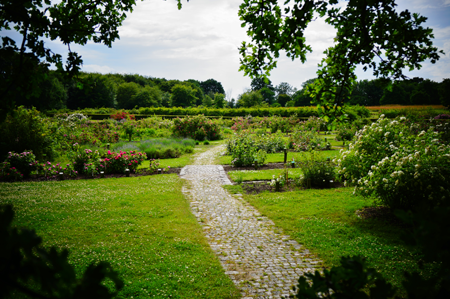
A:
[0,106,55,160]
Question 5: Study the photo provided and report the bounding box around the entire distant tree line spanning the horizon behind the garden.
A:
[12,71,450,111]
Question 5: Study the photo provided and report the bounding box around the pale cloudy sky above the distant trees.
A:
[3,0,450,97]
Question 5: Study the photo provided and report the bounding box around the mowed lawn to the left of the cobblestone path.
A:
[0,175,240,298]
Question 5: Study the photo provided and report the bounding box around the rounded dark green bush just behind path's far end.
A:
[173,114,221,141]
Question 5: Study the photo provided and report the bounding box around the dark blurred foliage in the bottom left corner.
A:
[0,205,124,298]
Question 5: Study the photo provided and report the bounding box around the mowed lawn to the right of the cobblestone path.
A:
[226,185,433,296]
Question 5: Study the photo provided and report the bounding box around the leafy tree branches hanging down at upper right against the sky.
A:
[239,0,443,122]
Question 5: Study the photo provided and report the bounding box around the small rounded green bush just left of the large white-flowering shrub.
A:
[296,151,335,188]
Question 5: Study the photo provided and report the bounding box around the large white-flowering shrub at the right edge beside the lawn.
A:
[335,117,450,209]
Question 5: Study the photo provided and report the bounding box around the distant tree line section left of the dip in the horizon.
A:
[16,71,228,110]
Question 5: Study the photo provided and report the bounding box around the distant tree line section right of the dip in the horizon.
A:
[236,77,450,107]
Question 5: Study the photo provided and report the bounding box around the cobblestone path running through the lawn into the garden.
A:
[180,146,321,298]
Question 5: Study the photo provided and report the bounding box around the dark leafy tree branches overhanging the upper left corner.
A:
[0,0,185,121]
